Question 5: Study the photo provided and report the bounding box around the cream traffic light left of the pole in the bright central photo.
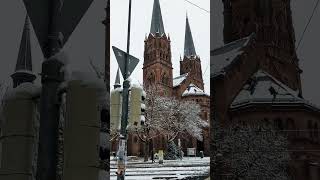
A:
[110,88,122,130]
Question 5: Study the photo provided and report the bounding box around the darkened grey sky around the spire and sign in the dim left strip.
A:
[0,0,106,86]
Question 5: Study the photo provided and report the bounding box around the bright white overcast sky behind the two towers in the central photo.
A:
[110,0,210,93]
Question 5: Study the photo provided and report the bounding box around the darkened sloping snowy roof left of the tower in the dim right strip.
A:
[210,34,255,77]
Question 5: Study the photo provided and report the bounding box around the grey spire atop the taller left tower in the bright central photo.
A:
[150,0,165,36]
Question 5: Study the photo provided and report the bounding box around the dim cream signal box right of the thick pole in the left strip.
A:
[63,80,100,180]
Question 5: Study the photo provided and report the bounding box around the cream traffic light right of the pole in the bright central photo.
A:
[129,86,146,128]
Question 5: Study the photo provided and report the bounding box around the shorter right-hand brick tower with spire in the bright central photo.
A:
[180,16,204,90]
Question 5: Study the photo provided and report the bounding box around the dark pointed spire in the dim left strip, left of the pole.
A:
[11,16,36,87]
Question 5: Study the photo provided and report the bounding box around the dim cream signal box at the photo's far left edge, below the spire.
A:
[0,84,38,180]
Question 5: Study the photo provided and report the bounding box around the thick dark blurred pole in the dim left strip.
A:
[36,0,63,180]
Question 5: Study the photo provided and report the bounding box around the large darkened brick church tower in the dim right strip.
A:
[222,0,302,94]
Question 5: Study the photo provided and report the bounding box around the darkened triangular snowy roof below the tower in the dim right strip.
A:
[231,70,304,107]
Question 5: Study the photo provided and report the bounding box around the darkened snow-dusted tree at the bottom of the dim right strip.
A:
[212,122,290,180]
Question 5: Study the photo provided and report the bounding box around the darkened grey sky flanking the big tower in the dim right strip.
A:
[210,0,320,105]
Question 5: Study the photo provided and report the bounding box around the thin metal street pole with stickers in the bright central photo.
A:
[117,0,131,180]
